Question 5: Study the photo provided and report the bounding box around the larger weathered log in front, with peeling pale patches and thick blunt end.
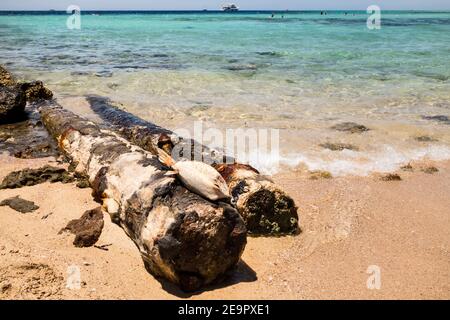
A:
[40,102,246,291]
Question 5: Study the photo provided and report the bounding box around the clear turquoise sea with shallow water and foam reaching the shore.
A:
[0,11,450,175]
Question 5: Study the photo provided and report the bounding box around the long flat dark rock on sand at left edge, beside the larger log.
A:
[0,166,74,189]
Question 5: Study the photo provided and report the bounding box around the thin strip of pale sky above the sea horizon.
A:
[0,0,450,10]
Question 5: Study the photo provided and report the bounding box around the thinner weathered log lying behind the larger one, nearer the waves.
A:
[88,96,299,235]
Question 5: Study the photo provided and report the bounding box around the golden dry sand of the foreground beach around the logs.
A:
[0,151,450,299]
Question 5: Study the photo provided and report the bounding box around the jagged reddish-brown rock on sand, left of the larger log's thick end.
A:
[59,207,104,248]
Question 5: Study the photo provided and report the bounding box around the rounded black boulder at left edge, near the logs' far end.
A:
[0,86,26,123]
